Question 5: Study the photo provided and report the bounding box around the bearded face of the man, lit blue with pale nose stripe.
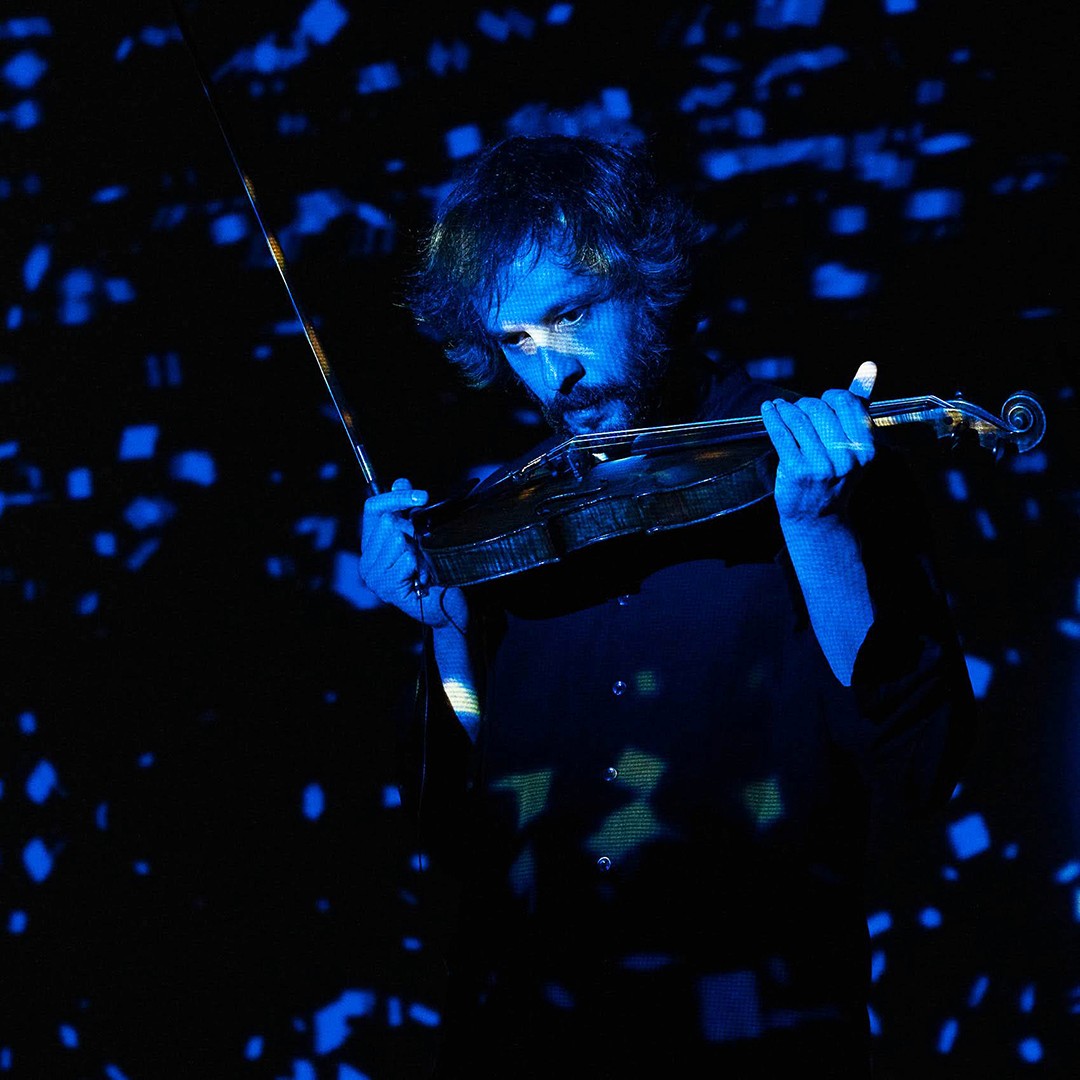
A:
[481,251,662,434]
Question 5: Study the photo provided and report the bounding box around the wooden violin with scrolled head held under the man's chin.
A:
[411,392,1047,585]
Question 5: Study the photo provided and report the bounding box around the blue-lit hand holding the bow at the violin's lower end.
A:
[360,480,469,633]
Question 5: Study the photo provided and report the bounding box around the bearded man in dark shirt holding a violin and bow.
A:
[361,136,971,1078]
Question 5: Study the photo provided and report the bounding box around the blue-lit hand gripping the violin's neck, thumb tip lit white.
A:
[761,361,877,524]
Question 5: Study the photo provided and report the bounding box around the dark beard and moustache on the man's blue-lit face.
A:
[530,304,669,435]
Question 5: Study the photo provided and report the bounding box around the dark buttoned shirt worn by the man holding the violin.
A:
[406,373,972,1080]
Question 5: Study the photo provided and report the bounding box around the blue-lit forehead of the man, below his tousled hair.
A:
[481,249,603,333]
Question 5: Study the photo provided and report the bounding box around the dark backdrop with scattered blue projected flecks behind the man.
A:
[0,0,1080,1080]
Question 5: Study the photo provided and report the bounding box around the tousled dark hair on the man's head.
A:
[407,135,702,387]
